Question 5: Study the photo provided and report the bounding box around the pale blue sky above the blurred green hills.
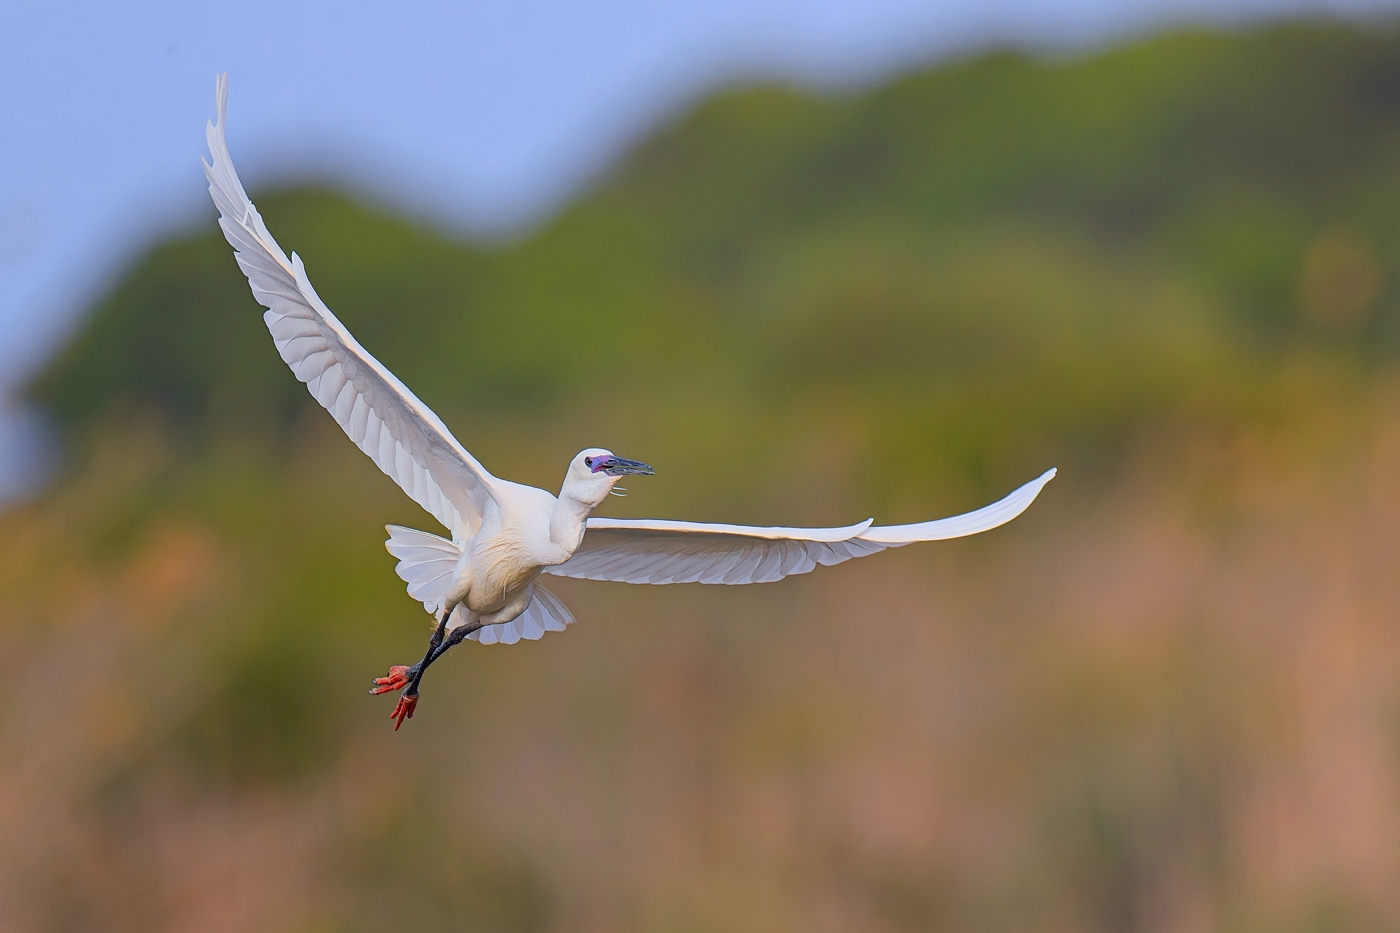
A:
[0,0,1400,497]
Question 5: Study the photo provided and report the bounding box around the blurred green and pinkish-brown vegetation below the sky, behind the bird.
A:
[8,14,1400,933]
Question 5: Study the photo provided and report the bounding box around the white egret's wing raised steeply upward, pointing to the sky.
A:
[204,74,496,542]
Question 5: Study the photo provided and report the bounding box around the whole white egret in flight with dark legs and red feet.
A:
[204,76,1056,728]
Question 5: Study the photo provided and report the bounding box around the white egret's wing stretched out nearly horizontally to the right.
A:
[545,469,1056,584]
